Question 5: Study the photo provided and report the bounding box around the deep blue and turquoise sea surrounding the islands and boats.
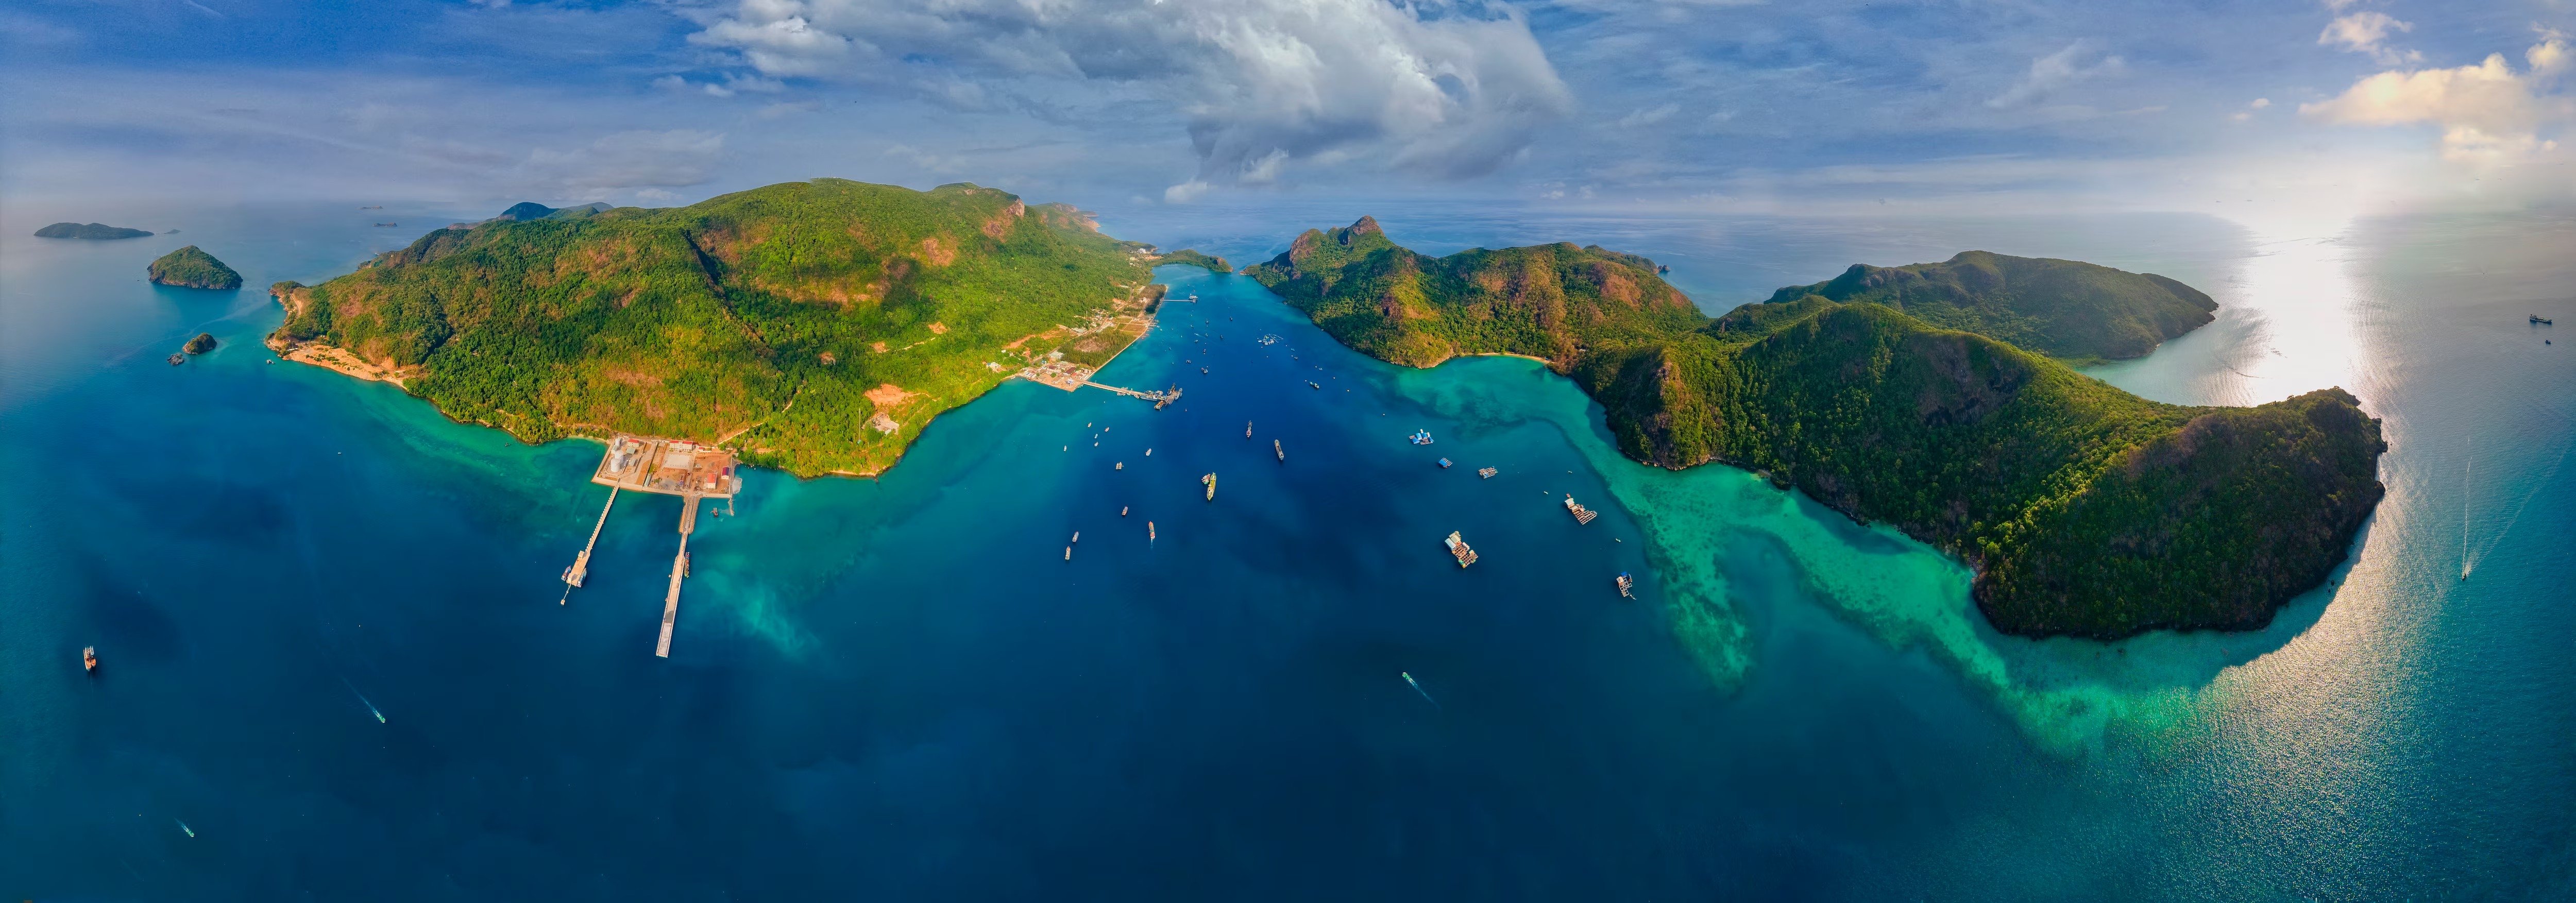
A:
[0,206,2576,900]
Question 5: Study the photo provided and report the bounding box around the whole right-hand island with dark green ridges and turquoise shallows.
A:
[1244,216,2388,638]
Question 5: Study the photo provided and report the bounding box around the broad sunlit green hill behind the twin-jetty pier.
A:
[270,180,1151,473]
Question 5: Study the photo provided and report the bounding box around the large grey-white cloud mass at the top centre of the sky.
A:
[690,0,1571,188]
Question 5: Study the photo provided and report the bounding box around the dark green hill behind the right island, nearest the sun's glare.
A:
[1772,252,2218,360]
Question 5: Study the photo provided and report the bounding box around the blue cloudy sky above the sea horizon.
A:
[0,0,2576,216]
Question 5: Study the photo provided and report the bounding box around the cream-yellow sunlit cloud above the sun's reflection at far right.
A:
[2298,39,2568,162]
